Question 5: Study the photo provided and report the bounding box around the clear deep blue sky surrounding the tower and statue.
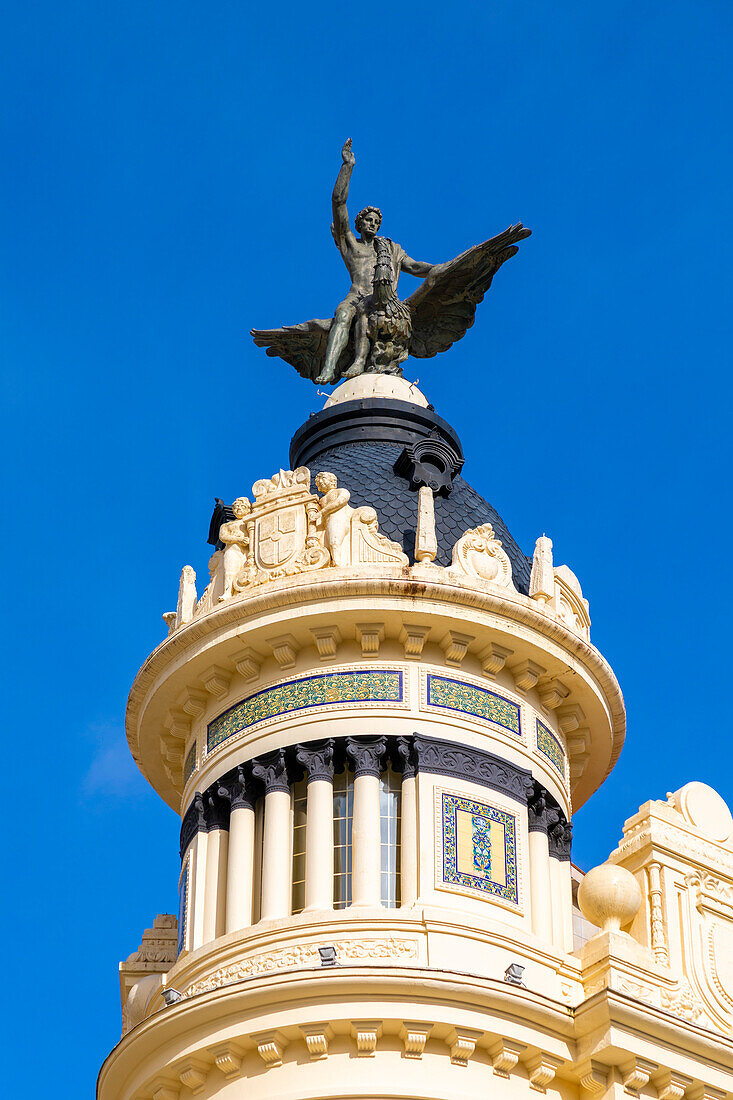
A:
[0,0,733,1098]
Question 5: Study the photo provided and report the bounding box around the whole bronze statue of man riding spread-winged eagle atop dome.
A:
[252,139,532,384]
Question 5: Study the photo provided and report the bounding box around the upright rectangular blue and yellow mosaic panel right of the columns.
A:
[440,791,519,905]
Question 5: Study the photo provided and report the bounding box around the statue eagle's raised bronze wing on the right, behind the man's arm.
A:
[407,222,532,359]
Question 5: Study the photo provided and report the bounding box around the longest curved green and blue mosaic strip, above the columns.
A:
[207,669,403,752]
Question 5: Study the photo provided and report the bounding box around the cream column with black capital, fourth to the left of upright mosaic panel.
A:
[252,749,293,921]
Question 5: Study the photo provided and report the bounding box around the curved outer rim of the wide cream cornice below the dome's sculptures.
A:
[125,565,625,806]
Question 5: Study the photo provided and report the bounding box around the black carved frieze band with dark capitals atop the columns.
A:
[180,734,572,860]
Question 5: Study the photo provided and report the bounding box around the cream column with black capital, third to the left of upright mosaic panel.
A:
[296,738,333,910]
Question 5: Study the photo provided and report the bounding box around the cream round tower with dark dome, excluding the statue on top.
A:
[99,375,620,1100]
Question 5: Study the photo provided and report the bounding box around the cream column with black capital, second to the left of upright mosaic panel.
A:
[347,737,386,906]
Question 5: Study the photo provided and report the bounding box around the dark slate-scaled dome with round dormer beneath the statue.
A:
[291,398,532,595]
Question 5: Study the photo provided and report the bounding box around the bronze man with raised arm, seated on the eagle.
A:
[316,138,434,383]
